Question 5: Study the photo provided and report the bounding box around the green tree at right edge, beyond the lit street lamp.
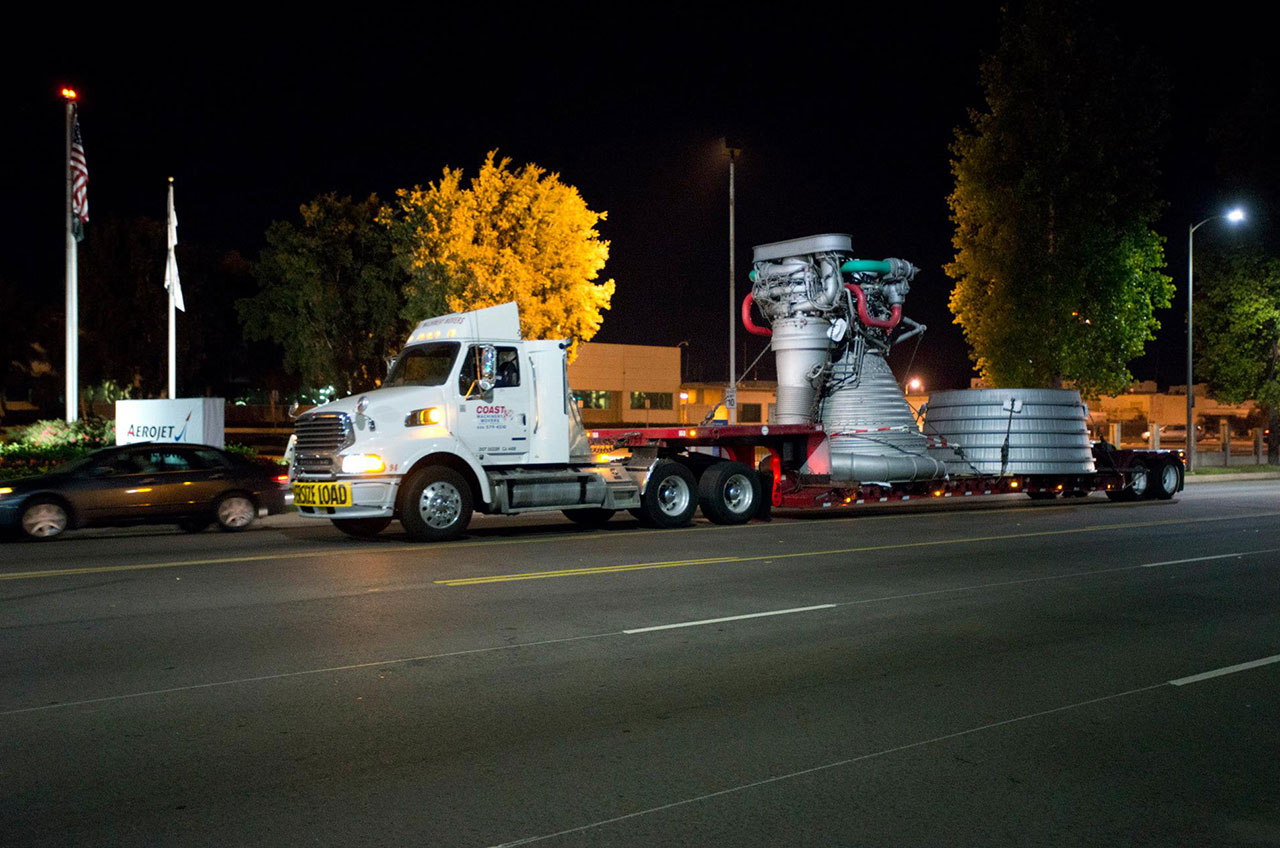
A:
[1196,250,1280,465]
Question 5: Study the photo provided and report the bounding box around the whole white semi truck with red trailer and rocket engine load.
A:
[289,234,1183,541]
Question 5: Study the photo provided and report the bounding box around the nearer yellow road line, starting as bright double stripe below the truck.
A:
[435,512,1280,587]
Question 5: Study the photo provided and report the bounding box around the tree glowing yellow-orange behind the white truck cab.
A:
[380,151,614,353]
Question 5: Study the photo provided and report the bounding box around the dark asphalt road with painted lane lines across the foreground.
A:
[0,480,1280,848]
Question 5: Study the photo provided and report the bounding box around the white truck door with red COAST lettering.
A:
[454,345,532,465]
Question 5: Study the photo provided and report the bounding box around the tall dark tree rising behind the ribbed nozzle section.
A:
[946,0,1172,396]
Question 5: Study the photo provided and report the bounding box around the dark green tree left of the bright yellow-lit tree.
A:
[237,193,408,395]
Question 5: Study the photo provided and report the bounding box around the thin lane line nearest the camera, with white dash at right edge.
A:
[481,655,1280,848]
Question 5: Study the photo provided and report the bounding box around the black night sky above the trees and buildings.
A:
[0,9,1274,388]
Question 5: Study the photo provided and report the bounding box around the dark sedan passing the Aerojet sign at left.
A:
[0,443,288,539]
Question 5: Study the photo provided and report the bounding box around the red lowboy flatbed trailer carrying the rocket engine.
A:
[588,424,1185,510]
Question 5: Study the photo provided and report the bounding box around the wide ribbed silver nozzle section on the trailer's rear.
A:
[924,388,1094,475]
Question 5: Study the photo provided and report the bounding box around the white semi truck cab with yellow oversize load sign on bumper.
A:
[289,304,652,539]
